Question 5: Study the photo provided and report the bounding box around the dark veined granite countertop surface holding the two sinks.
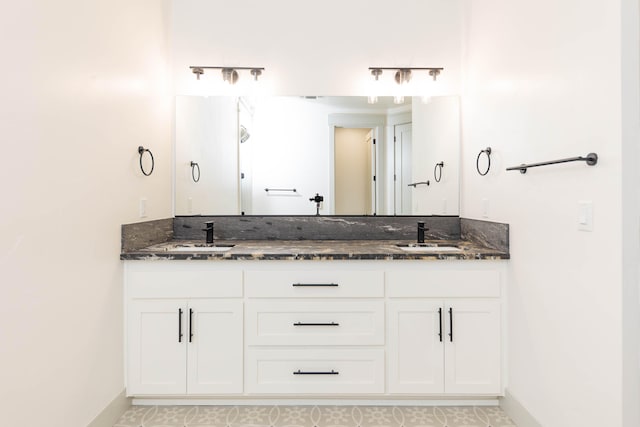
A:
[120,240,509,260]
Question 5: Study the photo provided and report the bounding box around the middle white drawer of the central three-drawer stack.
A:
[245,300,384,346]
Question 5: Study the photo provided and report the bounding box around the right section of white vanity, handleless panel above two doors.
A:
[387,270,502,395]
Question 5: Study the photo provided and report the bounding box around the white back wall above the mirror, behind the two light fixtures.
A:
[172,0,461,95]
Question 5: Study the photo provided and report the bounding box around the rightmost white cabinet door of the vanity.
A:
[445,300,501,395]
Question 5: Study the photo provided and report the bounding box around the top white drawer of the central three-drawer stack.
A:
[244,270,384,298]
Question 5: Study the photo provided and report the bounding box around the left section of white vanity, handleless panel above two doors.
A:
[126,263,243,396]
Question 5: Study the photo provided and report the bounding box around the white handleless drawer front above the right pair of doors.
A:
[386,270,500,298]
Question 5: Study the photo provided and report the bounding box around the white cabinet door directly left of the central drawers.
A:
[185,299,243,394]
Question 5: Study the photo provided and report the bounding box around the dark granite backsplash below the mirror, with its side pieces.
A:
[122,216,509,253]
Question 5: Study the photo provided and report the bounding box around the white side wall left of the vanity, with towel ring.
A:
[0,0,172,427]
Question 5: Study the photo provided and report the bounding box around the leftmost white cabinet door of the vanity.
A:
[127,300,187,395]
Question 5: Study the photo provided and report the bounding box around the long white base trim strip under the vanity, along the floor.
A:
[133,396,500,408]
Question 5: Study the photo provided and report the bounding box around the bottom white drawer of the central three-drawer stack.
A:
[245,349,384,395]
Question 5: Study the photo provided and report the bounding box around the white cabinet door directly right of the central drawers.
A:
[388,300,444,394]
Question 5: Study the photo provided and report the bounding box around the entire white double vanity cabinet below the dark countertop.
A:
[125,260,506,400]
